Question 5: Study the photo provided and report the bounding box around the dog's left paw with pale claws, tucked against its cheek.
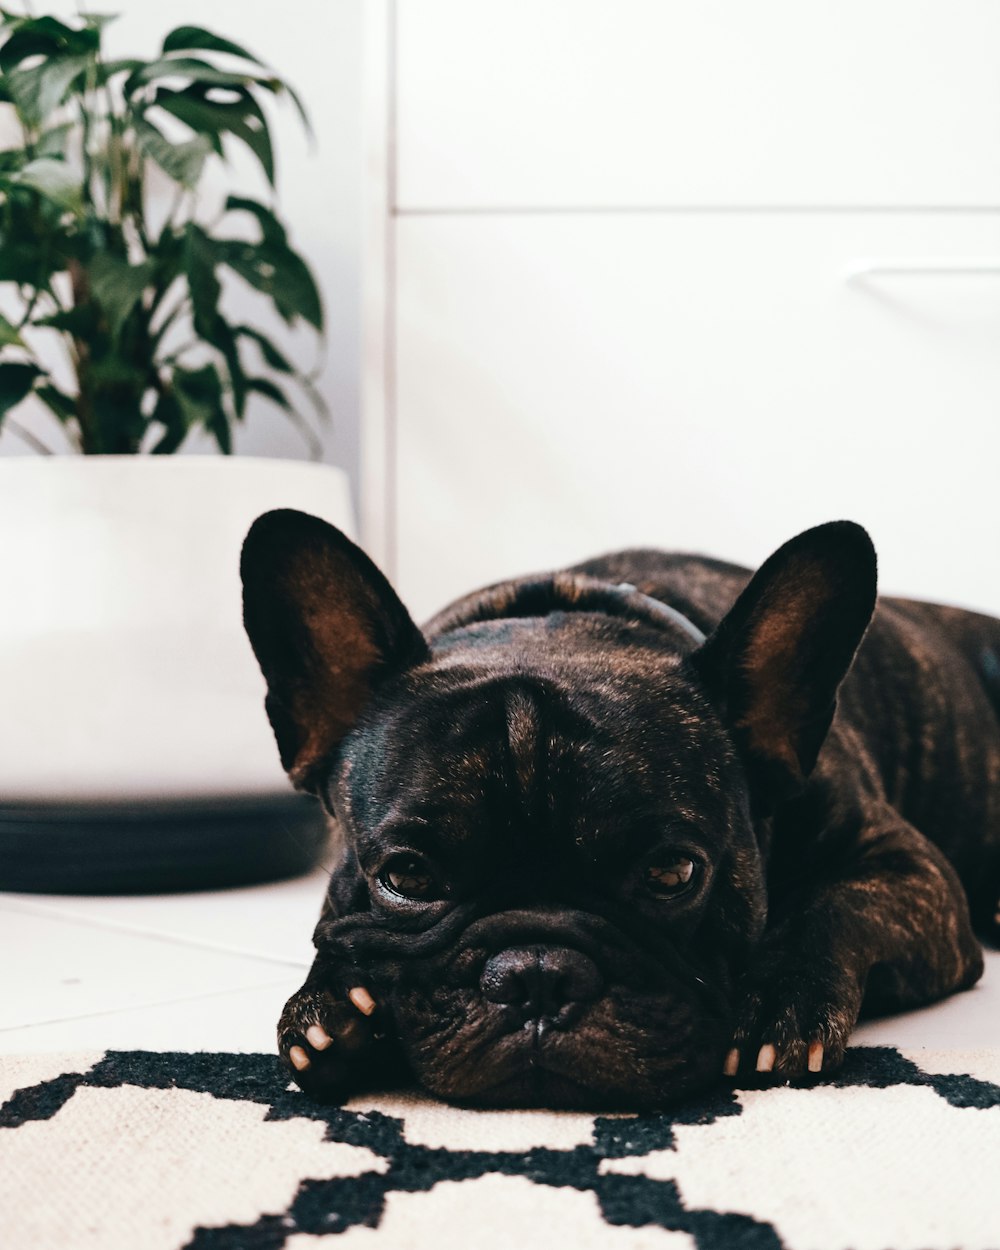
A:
[278,983,386,1101]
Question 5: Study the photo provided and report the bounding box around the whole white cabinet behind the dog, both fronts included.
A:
[363,0,1000,615]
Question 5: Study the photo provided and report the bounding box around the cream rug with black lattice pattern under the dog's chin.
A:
[0,1048,1000,1250]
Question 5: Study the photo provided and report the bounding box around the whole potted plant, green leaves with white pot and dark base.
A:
[0,10,351,889]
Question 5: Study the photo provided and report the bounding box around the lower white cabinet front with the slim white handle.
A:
[395,213,1000,625]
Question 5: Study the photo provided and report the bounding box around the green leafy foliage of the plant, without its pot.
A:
[0,6,323,455]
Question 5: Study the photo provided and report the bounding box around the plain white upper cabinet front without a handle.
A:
[395,0,1000,210]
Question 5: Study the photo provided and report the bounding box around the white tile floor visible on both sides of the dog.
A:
[0,870,1000,1054]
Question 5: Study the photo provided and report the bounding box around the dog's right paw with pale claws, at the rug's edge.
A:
[723,960,861,1081]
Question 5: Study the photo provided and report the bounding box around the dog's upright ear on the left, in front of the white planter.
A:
[240,509,428,793]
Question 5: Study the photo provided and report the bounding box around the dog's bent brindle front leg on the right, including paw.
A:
[725,811,983,1078]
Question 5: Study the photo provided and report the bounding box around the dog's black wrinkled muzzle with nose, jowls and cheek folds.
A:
[320,909,731,1110]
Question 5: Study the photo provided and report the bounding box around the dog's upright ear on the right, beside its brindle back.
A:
[691,521,876,814]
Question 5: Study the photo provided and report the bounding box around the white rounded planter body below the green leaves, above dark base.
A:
[0,456,354,888]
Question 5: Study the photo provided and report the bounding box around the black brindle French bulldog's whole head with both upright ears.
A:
[243,511,875,1106]
